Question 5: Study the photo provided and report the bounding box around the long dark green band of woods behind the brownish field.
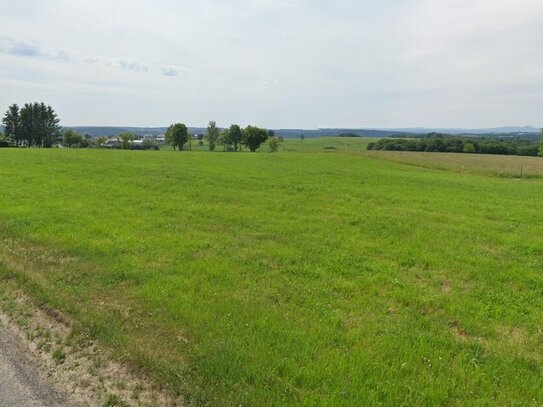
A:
[368,133,539,156]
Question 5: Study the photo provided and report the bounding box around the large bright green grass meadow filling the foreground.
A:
[0,140,543,406]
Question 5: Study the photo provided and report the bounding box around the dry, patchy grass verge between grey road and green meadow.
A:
[0,262,186,407]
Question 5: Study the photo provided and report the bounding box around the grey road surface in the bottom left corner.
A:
[0,322,73,407]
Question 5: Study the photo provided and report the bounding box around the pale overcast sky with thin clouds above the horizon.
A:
[0,0,543,128]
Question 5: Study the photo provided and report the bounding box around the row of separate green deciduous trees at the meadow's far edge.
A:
[166,121,283,152]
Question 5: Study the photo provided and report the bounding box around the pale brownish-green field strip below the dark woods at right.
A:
[367,151,543,178]
